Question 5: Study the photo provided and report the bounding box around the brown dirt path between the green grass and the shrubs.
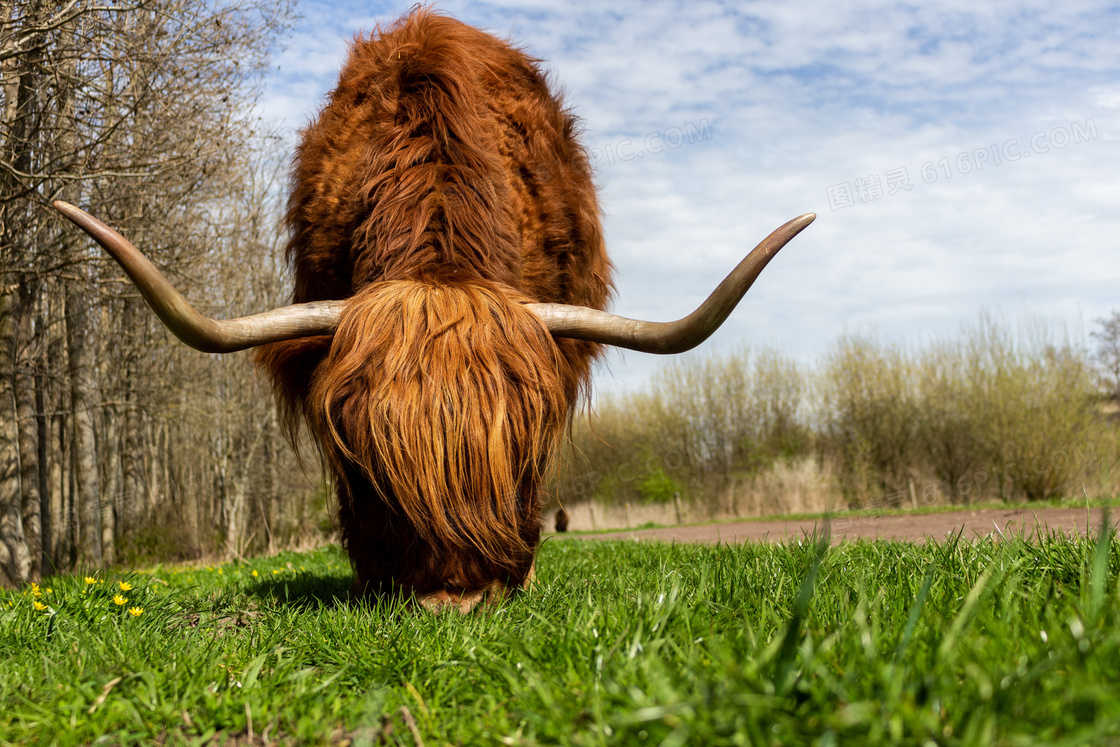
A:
[557,508,1120,543]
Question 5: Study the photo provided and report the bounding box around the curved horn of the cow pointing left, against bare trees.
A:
[54,200,344,353]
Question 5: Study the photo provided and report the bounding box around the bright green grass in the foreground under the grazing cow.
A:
[0,528,1120,747]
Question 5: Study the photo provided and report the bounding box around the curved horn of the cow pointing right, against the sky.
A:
[528,213,816,355]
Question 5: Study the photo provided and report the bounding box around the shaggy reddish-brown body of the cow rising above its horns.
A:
[280,10,610,308]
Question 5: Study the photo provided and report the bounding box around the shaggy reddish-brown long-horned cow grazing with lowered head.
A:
[56,9,813,610]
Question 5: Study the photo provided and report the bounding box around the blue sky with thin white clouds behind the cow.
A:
[260,0,1120,392]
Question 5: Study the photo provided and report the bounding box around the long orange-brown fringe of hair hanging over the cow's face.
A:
[308,280,572,582]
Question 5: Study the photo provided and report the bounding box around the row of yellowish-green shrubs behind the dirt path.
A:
[552,315,1106,505]
